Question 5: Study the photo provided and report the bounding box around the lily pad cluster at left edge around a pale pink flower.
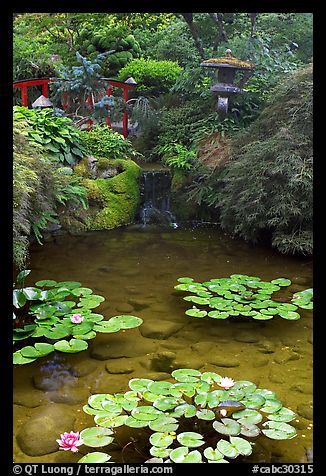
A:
[13,270,143,364]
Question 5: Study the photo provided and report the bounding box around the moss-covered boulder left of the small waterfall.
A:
[75,157,141,230]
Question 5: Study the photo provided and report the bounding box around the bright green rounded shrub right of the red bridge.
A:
[118,58,182,95]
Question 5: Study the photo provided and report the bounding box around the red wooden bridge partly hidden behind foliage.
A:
[13,78,137,138]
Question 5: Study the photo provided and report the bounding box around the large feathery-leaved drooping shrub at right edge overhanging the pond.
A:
[219,65,313,254]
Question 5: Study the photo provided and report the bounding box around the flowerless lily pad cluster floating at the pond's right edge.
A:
[175,274,313,321]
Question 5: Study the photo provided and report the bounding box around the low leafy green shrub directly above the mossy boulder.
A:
[81,124,137,159]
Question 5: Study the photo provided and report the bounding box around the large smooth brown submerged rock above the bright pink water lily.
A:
[16,404,75,456]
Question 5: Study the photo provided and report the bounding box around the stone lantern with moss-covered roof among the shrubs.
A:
[200,49,254,116]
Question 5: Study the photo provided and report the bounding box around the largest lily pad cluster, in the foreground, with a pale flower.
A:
[79,368,296,463]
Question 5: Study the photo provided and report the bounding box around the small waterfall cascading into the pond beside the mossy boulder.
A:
[139,170,177,228]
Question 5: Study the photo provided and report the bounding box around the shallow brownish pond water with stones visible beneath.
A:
[14,226,312,463]
